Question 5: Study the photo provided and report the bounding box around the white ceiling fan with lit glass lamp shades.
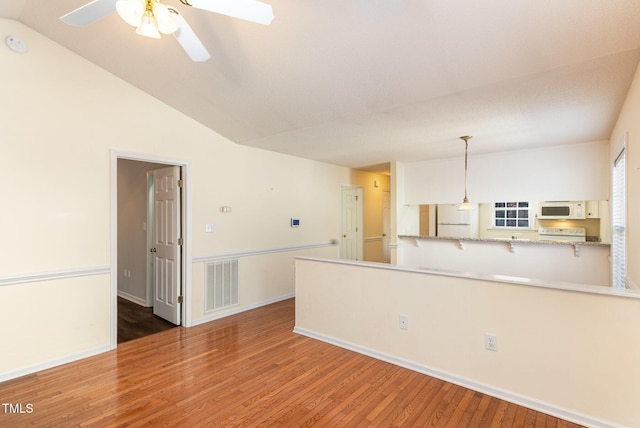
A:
[60,0,273,62]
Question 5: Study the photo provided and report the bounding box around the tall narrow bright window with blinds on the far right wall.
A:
[611,148,626,288]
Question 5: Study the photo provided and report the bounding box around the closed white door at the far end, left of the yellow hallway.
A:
[340,187,362,260]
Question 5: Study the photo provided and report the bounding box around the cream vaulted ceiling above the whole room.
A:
[0,0,640,169]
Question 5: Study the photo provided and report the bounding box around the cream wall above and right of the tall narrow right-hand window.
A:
[609,61,640,287]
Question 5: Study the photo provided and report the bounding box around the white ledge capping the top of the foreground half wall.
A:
[296,256,640,299]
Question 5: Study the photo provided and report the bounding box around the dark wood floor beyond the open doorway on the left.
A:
[118,297,176,343]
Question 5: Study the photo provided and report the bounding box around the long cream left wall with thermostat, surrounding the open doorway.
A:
[0,20,350,380]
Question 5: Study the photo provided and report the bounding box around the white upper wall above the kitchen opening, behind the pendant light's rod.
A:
[402,141,609,205]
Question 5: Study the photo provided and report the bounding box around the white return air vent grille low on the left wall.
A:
[205,259,238,311]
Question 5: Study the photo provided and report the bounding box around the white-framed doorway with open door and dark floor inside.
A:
[111,153,190,348]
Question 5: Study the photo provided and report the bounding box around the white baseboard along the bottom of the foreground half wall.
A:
[293,326,620,428]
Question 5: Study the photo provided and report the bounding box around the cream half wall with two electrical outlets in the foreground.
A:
[295,260,640,427]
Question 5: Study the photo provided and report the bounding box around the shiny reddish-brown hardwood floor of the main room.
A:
[0,300,577,427]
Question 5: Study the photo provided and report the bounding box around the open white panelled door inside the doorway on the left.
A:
[151,166,182,325]
